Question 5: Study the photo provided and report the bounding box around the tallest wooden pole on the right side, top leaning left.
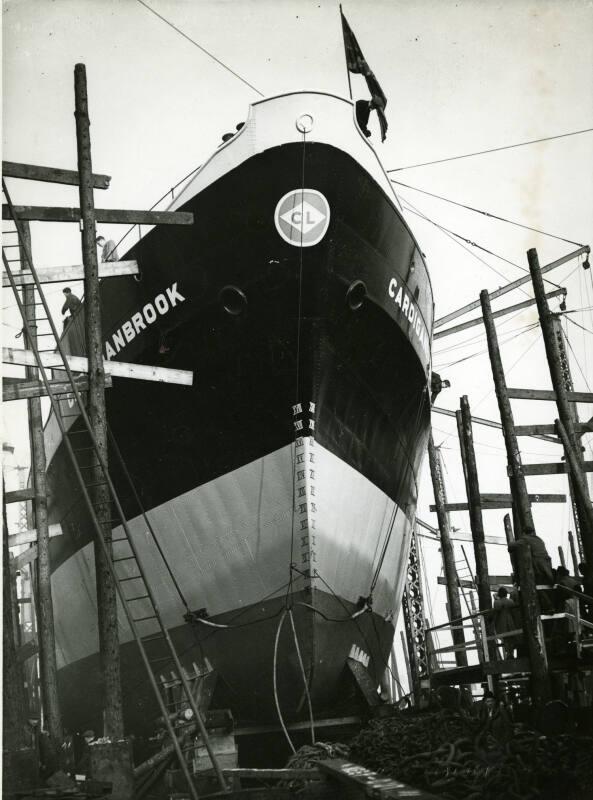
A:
[527,248,593,564]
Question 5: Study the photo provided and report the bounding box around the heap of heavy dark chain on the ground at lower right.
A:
[350,710,593,800]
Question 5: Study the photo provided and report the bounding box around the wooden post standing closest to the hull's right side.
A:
[428,432,467,667]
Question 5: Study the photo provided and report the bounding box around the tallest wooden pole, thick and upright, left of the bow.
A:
[74,64,124,740]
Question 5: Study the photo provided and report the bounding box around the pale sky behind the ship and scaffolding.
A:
[3,0,593,676]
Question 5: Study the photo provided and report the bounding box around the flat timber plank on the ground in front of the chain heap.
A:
[317,758,437,800]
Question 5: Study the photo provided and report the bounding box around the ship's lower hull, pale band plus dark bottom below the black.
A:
[53,437,411,734]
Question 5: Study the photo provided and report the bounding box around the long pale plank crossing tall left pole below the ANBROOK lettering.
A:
[2,347,194,386]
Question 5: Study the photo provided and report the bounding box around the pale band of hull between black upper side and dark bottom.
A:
[52,437,410,667]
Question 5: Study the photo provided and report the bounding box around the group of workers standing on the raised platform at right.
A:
[493,528,593,659]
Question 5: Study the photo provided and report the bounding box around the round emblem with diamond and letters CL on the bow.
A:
[274,189,329,247]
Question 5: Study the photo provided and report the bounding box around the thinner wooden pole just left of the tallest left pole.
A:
[19,222,63,753]
